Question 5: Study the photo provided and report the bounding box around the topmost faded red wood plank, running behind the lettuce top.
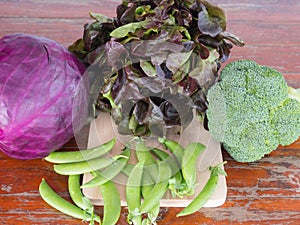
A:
[0,0,300,21]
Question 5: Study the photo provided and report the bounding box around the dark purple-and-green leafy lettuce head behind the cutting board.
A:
[69,0,244,137]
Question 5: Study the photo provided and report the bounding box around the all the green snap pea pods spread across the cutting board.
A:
[39,138,226,225]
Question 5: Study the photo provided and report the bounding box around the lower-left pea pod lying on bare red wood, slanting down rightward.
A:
[39,179,101,223]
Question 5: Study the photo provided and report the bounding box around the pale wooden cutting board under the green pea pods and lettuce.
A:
[83,113,227,207]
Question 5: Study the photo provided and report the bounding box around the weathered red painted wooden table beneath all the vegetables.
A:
[0,0,300,225]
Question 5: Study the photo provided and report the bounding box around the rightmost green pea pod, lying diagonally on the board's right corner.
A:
[176,162,226,217]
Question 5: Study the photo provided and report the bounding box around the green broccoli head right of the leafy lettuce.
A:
[206,60,300,162]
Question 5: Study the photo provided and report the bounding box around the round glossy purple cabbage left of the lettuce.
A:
[0,34,89,159]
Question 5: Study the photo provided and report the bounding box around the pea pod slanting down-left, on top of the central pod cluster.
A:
[139,161,172,213]
